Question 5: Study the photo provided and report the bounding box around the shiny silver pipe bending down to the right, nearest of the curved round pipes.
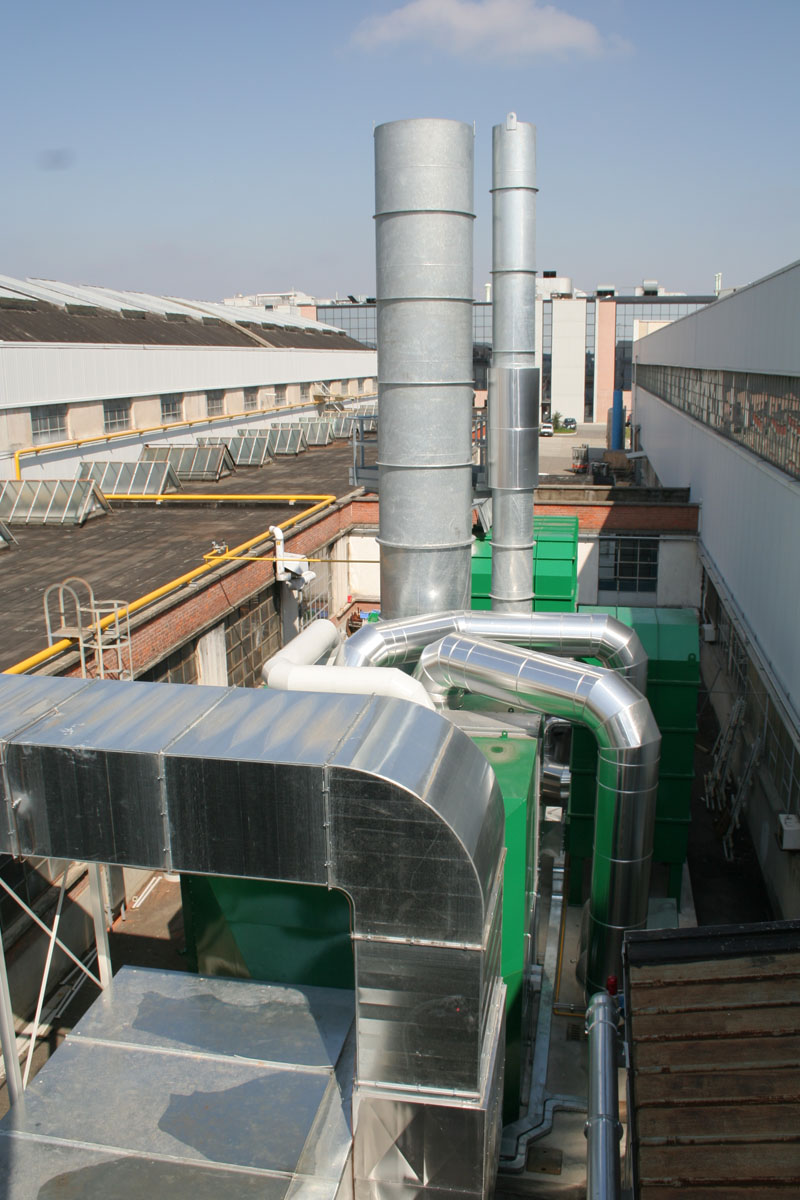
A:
[415,634,661,992]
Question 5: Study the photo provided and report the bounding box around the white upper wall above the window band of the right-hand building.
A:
[636,263,800,376]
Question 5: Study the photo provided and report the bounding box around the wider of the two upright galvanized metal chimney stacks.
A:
[375,120,474,617]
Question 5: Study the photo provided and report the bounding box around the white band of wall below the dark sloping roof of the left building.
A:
[0,343,378,408]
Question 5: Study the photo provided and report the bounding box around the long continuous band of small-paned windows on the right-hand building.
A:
[636,364,800,479]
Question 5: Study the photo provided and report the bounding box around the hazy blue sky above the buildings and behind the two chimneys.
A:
[6,0,800,299]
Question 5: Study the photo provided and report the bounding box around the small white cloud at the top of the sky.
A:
[353,0,625,60]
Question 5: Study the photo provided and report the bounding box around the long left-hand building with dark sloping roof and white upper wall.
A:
[0,276,377,478]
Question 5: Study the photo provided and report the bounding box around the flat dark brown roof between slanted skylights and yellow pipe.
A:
[0,440,369,671]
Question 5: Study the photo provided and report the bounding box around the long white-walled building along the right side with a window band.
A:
[633,263,800,917]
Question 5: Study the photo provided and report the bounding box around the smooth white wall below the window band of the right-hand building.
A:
[636,388,800,708]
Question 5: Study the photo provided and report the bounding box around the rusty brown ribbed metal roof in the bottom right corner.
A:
[626,922,800,1200]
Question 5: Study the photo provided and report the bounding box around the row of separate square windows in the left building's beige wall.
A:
[30,379,372,445]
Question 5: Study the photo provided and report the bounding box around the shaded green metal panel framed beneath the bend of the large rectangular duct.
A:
[181,875,354,988]
